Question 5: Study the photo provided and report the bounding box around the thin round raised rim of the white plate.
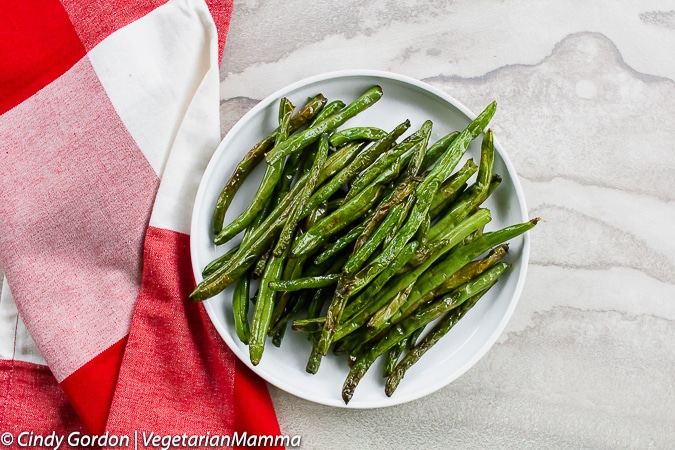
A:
[190,69,530,409]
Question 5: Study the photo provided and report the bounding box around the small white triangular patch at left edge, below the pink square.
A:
[0,271,46,365]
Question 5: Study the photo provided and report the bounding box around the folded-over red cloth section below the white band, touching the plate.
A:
[107,227,280,448]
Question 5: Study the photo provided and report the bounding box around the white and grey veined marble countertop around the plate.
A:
[221,0,675,449]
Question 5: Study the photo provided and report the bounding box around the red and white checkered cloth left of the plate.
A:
[0,0,279,442]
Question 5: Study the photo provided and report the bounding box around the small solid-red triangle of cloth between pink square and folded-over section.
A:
[61,337,127,434]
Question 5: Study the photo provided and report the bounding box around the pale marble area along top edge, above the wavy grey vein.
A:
[222,0,675,98]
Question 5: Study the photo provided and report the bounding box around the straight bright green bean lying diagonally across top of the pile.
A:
[265,86,382,164]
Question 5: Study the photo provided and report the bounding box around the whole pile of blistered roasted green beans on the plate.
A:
[190,86,539,403]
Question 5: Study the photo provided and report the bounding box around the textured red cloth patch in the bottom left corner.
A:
[0,360,85,436]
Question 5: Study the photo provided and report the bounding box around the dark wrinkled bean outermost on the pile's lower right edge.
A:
[384,288,489,397]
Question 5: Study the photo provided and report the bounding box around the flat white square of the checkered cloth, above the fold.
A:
[88,0,219,177]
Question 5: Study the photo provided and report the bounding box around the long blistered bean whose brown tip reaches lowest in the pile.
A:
[342,263,508,403]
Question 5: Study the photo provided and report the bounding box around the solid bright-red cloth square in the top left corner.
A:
[0,0,86,114]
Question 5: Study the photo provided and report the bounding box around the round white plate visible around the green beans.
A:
[190,71,529,408]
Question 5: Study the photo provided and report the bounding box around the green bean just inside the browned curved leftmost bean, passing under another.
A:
[214,98,293,245]
